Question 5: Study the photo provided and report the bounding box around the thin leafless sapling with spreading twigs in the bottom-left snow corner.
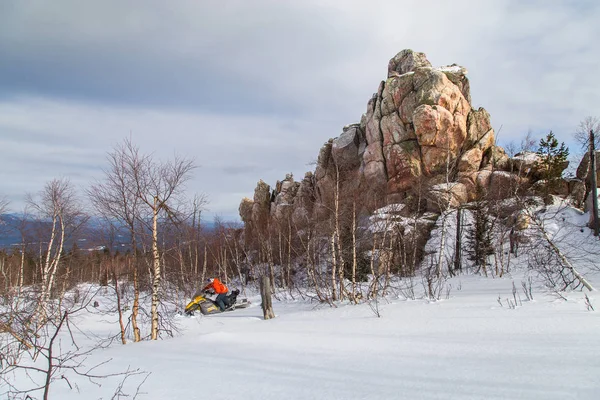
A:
[0,291,148,399]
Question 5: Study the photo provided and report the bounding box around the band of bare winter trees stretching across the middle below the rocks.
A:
[0,119,598,342]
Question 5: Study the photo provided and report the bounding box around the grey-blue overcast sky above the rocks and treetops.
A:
[0,0,600,220]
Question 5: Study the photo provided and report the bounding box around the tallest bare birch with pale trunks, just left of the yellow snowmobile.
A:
[89,139,195,341]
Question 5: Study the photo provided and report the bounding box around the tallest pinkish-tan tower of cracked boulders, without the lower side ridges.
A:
[363,50,494,193]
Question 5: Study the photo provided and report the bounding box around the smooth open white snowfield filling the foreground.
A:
[5,276,600,400]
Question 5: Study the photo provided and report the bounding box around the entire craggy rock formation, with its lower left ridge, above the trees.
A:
[240,50,572,231]
